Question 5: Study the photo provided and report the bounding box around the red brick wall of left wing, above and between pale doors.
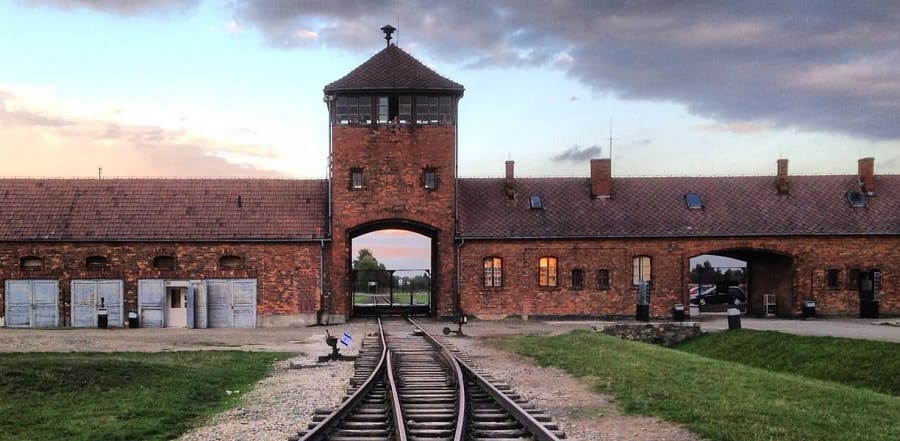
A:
[0,243,320,325]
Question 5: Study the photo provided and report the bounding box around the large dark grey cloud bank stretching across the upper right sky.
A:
[234,0,900,141]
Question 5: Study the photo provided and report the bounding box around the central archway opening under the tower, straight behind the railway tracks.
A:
[347,219,439,317]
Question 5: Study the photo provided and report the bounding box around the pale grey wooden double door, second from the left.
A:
[72,280,124,328]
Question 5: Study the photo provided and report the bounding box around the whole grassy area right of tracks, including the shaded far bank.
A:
[501,330,900,441]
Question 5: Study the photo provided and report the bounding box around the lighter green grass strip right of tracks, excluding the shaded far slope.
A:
[501,331,900,441]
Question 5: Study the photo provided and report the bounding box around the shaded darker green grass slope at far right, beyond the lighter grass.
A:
[676,329,900,396]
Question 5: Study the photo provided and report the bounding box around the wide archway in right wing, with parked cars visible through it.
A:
[685,248,796,317]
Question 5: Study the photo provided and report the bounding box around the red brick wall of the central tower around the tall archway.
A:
[326,125,456,316]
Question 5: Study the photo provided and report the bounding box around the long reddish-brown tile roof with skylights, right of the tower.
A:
[458,175,900,238]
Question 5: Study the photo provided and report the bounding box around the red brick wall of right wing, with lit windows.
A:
[461,237,900,318]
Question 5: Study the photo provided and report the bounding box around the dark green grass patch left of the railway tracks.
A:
[0,351,287,441]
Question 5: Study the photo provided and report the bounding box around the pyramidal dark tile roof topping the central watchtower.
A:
[325,44,464,95]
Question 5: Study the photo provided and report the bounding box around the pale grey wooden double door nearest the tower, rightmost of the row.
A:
[206,279,256,328]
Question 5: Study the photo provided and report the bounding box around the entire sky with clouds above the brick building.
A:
[0,0,900,264]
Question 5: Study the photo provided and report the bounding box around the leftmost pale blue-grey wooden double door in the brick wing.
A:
[6,280,59,328]
